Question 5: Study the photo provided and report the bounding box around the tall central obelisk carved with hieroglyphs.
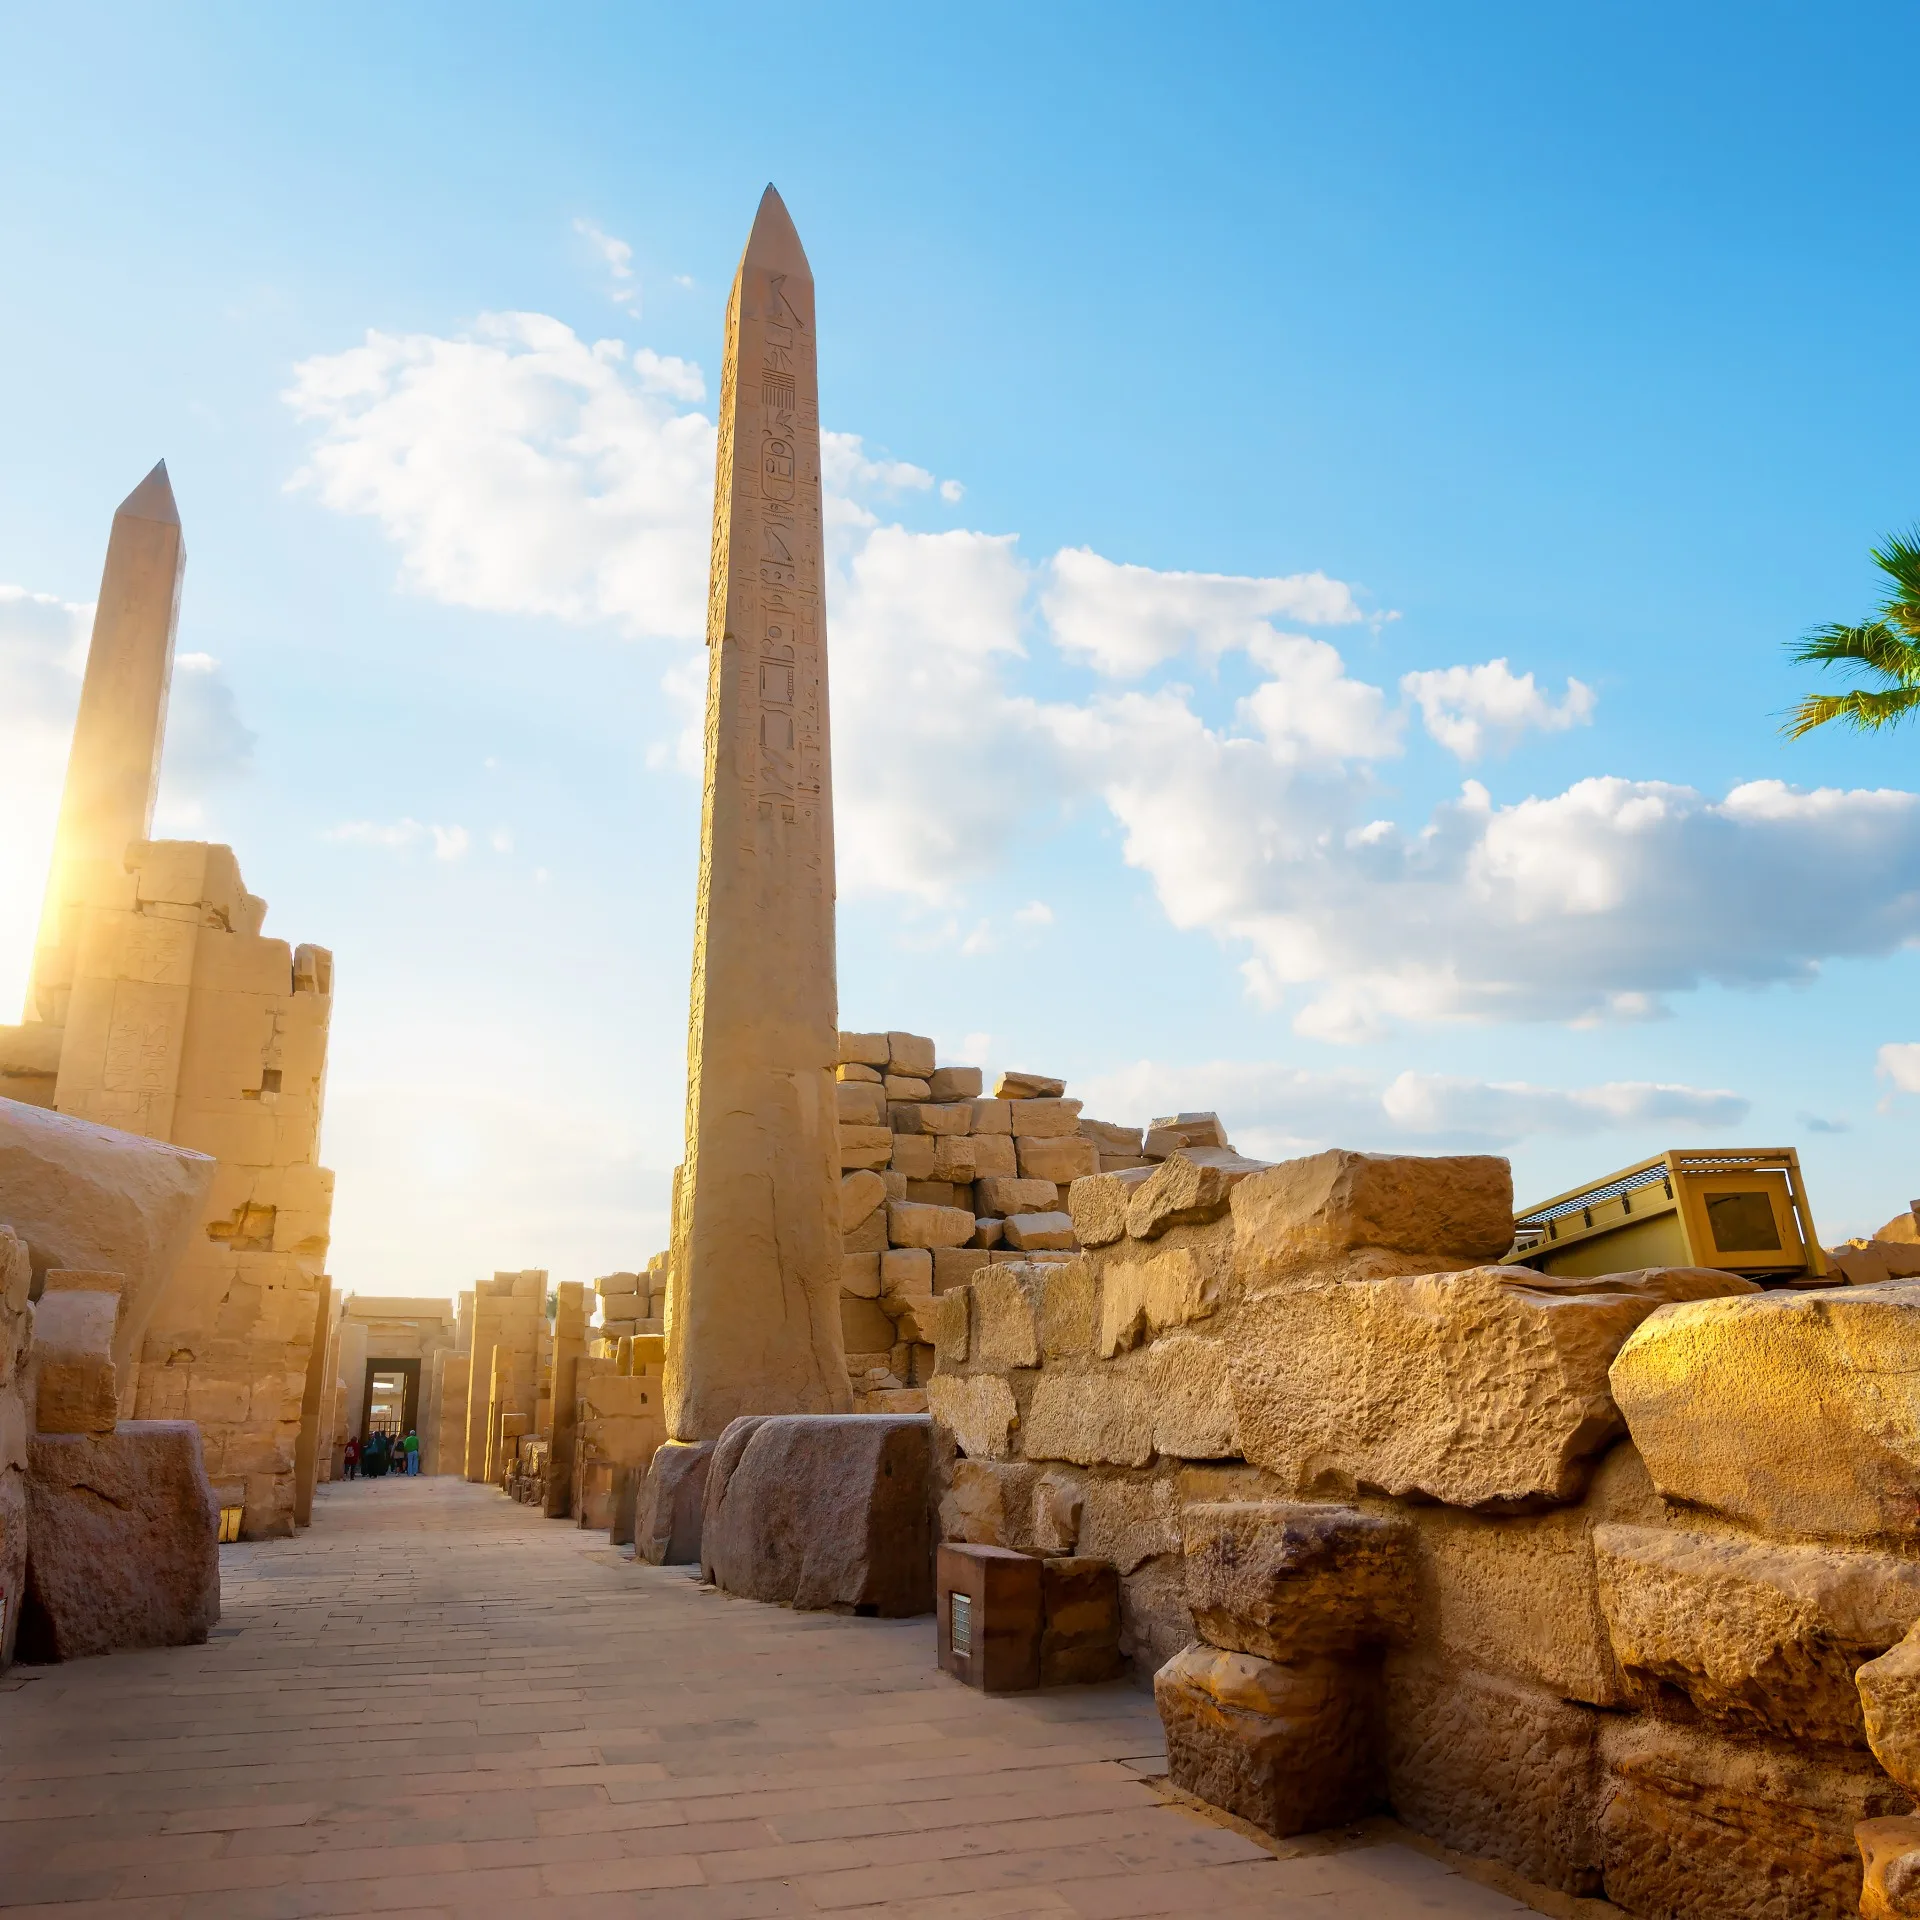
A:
[666,186,852,1440]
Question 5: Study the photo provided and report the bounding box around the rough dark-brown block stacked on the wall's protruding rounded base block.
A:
[1175,1501,1413,1663]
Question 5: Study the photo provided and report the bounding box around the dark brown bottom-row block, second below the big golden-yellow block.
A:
[1599,1718,1905,1920]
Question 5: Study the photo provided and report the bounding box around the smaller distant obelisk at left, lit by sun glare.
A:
[27,461,186,1027]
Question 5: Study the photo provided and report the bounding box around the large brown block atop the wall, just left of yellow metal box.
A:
[1233,1148,1513,1279]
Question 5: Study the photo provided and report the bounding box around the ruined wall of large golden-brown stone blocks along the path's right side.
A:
[929,1152,1920,1920]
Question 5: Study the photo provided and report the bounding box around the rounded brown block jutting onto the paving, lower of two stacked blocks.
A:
[1154,1647,1380,1839]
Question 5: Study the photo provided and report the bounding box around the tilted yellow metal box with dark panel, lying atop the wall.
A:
[1507,1146,1828,1284]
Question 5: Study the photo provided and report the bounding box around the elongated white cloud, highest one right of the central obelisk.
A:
[1041,547,1363,680]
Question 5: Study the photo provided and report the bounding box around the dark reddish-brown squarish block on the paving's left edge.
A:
[19,1421,221,1661]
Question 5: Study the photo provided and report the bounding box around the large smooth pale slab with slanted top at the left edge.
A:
[0,1100,215,1367]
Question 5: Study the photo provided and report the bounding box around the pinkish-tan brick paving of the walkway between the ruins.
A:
[0,1480,1528,1920]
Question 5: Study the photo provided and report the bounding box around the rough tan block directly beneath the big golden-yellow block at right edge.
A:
[1594,1526,1920,1772]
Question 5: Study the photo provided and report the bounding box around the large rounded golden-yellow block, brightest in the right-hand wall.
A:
[1613,1281,1920,1540]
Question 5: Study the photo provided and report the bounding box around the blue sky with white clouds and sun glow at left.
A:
[0,0,1920,1294]
